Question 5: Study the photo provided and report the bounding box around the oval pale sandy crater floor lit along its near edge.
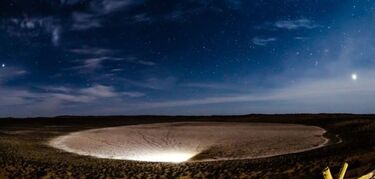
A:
[49,122,328,163]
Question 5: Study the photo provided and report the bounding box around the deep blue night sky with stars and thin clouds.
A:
[0,0,375,117]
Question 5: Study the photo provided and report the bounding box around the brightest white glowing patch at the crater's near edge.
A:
[122,152,195,163]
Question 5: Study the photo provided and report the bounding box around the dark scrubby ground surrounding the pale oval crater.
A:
[0,114,375,179]
